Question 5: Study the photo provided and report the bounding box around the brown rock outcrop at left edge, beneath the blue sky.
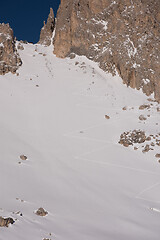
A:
[0,23,22,75]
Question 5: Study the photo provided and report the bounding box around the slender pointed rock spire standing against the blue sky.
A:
[38,8,55,46]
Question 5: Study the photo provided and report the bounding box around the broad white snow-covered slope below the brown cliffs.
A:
[0,44,160,240]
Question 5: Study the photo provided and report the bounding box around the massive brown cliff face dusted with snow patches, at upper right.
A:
[54,0,160,101]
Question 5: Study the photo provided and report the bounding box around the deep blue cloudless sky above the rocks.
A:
[0,0,60,43]
